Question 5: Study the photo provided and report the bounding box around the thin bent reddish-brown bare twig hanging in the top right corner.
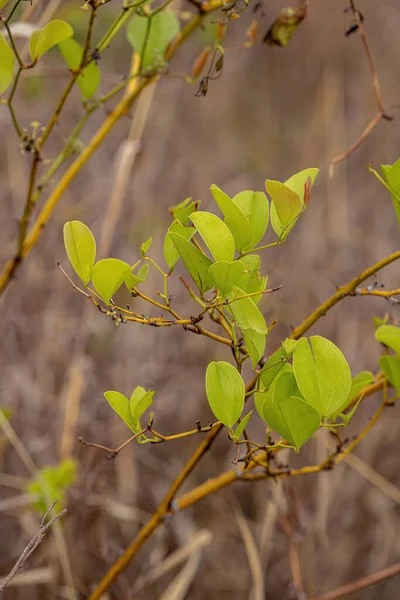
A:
[331,0,393,168]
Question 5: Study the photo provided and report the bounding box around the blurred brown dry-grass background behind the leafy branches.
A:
[0,0,400,600]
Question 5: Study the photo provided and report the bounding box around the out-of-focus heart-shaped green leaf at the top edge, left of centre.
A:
[127,10,180,69]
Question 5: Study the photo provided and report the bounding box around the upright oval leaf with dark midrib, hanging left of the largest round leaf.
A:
[206,361,245,427]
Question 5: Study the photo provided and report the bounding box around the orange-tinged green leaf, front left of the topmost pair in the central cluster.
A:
[265,179,302,241]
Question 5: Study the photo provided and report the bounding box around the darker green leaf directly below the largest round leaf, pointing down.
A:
[262,396,320,452]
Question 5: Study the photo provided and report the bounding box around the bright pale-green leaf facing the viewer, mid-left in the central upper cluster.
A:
[190,211,235,261]
